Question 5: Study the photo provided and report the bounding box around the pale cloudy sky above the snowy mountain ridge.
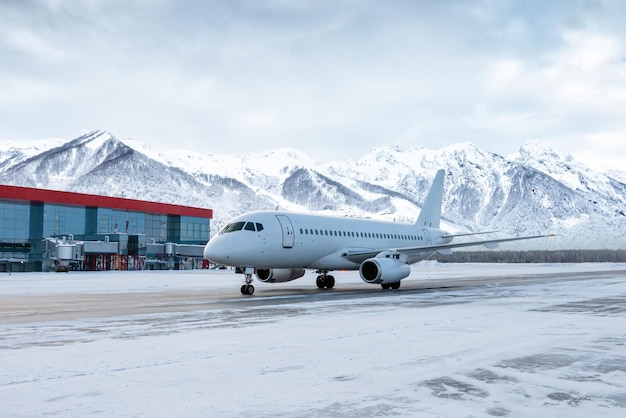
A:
[0,0,626,170]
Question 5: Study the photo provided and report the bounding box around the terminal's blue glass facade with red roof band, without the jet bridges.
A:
[0,185,211,267]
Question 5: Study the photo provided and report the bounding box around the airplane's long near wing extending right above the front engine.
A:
[341,234,553,263]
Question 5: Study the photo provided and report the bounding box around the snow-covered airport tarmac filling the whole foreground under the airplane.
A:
[0,262,626,417]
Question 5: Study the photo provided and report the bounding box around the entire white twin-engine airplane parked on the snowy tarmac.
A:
[204,170,550,295]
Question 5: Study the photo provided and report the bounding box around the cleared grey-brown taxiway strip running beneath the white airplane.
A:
[0,266,626,324]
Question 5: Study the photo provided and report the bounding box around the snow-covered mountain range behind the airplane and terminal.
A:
[0,131,626,249]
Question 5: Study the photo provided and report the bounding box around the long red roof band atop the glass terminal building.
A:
[0,184,213,218]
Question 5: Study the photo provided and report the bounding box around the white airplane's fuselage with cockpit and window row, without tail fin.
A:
[204,212,450,270]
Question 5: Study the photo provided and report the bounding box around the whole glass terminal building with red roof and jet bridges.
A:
[0,185,213,272]
